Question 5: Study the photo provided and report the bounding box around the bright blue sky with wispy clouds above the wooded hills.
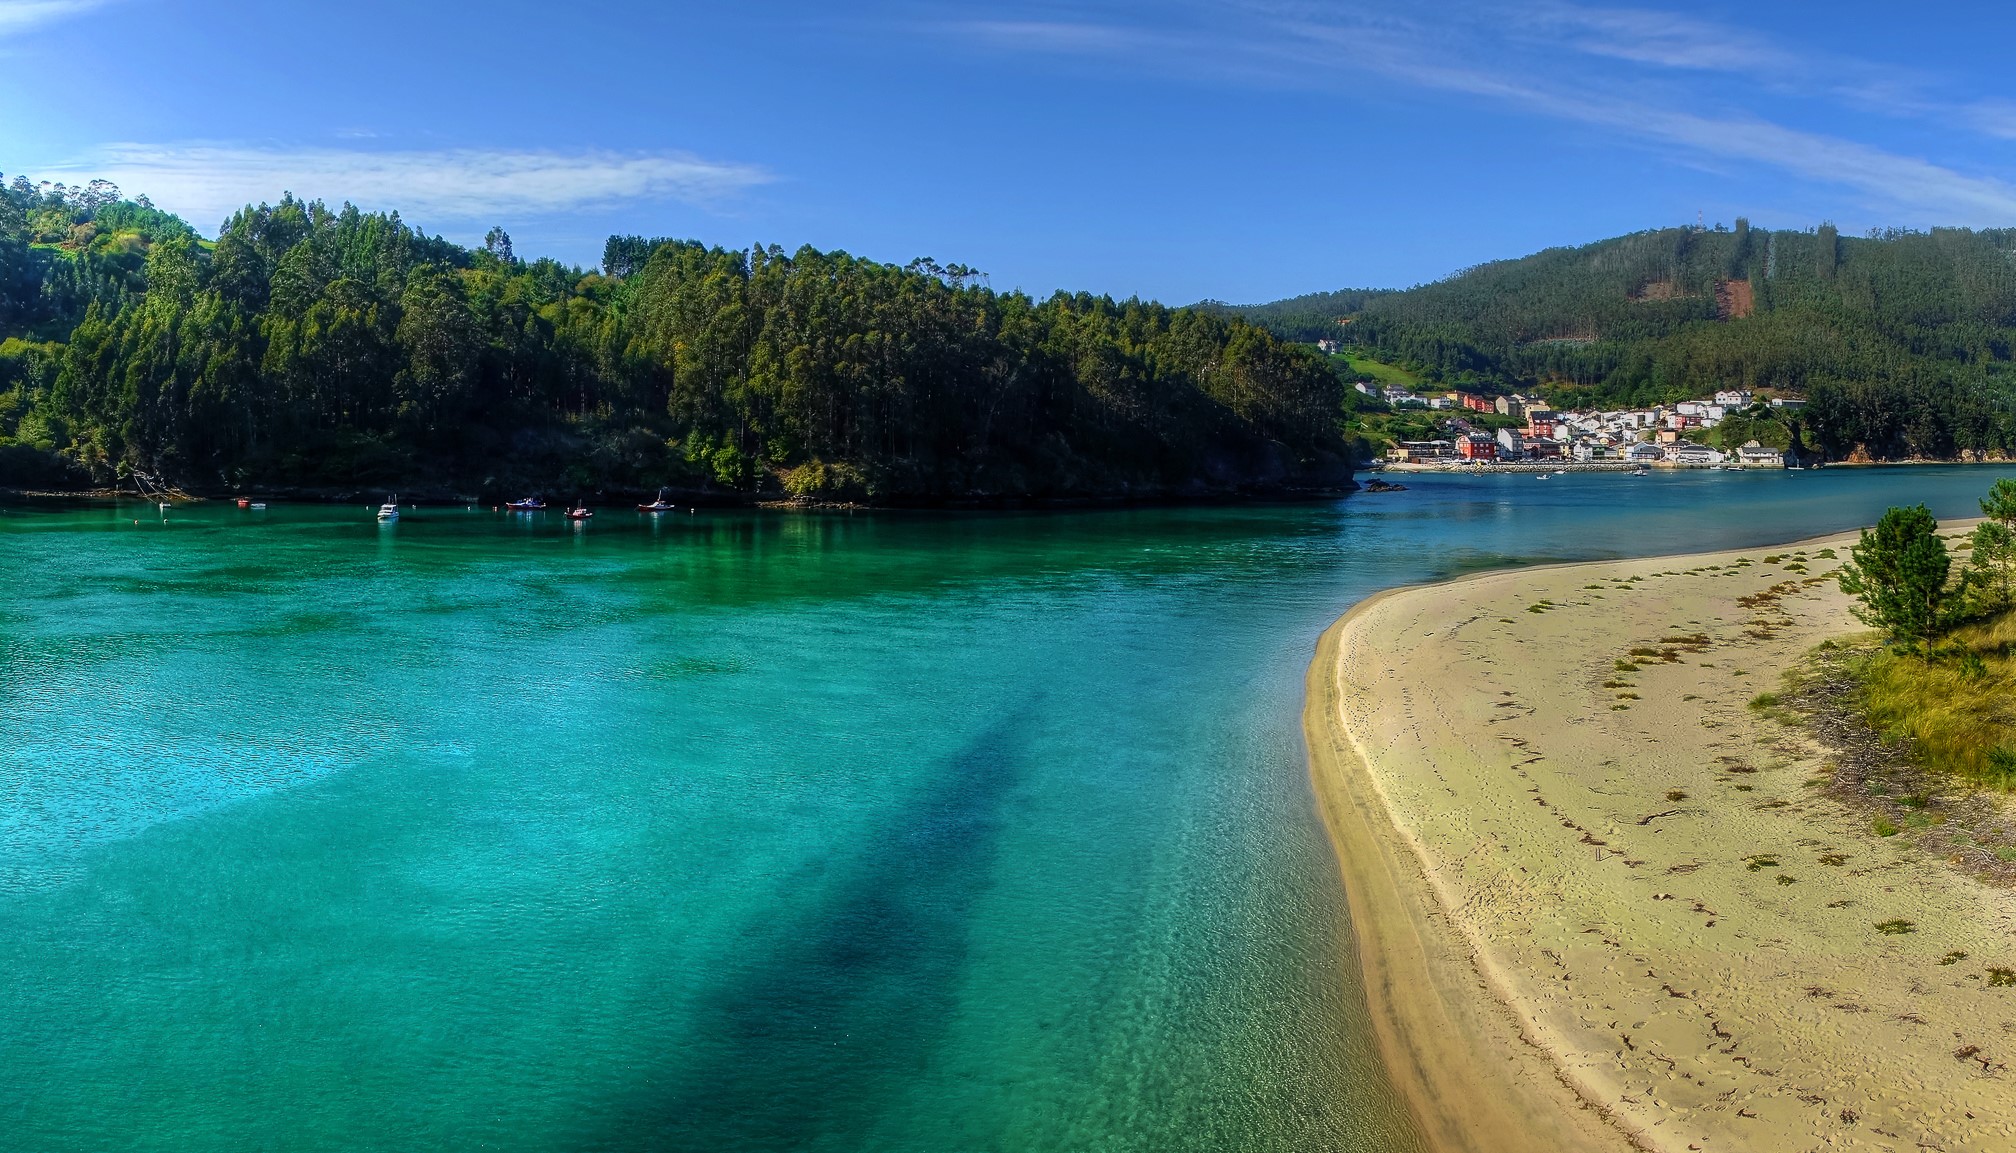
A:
[0,0,2016,302]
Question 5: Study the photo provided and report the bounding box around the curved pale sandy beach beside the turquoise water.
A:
[1304,534,2016,1153]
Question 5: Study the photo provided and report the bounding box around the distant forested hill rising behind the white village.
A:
[1232,220,2016,460]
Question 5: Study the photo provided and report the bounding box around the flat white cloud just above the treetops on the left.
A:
[40,143,774,226]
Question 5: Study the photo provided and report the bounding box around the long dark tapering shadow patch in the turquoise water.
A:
[597,699,1038,1153]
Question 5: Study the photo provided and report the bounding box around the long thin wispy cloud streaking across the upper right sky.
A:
[948,0,2016,224]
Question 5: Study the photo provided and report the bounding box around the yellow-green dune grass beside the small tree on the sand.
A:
[1853,613,2016,788]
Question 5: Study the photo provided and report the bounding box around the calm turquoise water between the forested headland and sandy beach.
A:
[0,468,1996,1153]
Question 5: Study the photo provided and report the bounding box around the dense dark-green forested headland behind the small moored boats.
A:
[0,177,1349,502]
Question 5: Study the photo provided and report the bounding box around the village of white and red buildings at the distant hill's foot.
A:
[1355,381,1806,468]
